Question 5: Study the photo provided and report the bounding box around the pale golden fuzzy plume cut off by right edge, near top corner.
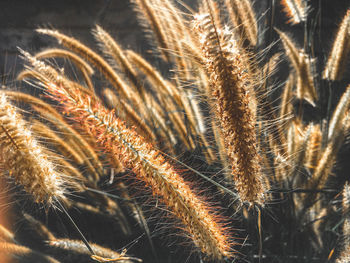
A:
[323,10,350,80]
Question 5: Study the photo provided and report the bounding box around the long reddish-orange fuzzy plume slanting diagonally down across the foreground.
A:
[41,76,232,259]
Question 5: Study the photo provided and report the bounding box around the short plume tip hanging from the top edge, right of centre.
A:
[281,0,309,25]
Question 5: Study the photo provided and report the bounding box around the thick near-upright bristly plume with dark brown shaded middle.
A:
[196,15,266,205]
